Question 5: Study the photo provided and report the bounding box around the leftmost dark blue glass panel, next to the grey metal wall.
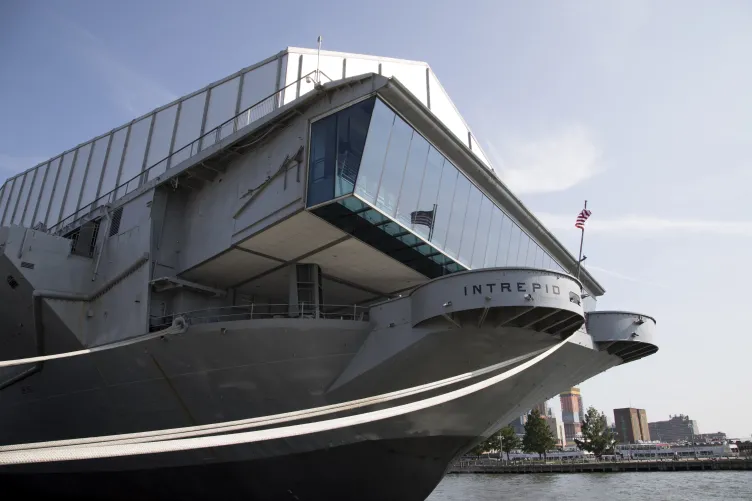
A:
[308,115,337,207]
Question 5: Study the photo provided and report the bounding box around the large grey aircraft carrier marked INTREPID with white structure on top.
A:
[0,48,657,501]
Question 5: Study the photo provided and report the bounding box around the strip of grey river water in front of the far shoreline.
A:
[427,471,752,501]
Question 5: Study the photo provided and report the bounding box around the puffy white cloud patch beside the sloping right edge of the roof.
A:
[488,124,603,193]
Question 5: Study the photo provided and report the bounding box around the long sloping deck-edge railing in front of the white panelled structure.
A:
[47,70,333,233]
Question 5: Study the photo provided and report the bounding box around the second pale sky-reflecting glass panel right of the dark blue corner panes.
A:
[376,117,414,217]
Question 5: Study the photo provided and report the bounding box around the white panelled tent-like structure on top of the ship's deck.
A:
[0,48,490,233]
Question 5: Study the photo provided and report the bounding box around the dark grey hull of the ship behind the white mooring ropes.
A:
[0,320,620,500]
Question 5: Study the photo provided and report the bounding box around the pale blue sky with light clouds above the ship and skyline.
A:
[0,0,752,437]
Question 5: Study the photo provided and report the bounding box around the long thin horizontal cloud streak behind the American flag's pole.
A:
[536,213,752,237]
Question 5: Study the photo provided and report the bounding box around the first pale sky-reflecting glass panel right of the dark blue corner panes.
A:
[355,99,395,203]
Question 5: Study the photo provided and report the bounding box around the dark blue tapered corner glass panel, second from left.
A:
[334,99,374,197]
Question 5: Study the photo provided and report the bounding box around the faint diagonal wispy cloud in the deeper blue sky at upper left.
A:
[48,12,178,116]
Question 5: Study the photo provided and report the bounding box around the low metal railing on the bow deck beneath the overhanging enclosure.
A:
[149,303,370,331]
